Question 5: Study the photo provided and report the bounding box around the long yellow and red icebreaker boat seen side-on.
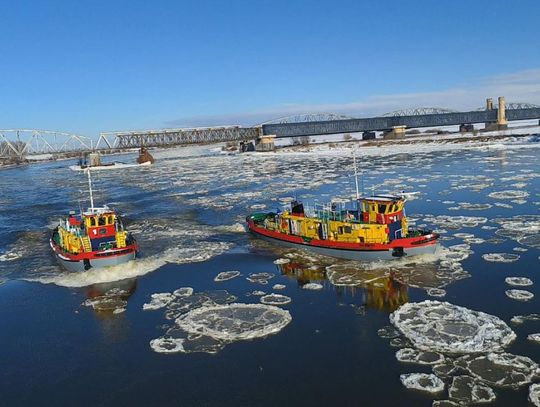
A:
[246,195,439,261]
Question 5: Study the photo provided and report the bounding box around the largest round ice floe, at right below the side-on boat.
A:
[390,300,516,354]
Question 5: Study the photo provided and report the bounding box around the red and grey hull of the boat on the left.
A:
[50,241,137,272]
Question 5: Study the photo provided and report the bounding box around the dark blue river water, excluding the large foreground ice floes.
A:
[0,140,540,406]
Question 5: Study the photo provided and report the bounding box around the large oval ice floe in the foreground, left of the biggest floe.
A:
[176,303,292,342]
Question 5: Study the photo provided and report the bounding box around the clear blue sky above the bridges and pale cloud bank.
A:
[0,0,540,136]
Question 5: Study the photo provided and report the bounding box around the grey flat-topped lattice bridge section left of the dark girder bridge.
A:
[101,126,261,148]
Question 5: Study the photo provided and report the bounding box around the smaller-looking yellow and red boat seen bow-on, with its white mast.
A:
[49,170,139,272]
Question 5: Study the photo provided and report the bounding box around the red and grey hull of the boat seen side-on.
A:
[248,222,438,261]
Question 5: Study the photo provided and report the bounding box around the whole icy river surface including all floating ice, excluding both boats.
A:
[0,136,540,406]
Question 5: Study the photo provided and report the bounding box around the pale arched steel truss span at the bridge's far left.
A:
[0,129,101,159]
